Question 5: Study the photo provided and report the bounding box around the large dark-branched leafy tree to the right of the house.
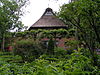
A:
[60,0,100,65]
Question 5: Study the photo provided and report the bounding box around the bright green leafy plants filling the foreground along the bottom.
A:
[0,51,100,75]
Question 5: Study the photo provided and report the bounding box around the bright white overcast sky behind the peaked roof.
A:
[21,0,69,28]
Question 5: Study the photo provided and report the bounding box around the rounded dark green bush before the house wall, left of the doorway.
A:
[14,39,45,61]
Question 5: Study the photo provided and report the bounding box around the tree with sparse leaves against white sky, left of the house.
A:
[0,0,27,51]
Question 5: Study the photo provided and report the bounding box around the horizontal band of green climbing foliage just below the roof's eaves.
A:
[14,29,69,39]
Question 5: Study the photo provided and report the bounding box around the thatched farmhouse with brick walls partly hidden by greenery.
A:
[29,8,70,48]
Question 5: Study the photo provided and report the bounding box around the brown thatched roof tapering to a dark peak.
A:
[29,8,66,30]
